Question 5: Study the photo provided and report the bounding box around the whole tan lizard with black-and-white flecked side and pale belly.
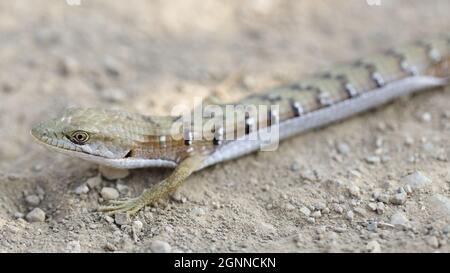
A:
[31,36,450,214]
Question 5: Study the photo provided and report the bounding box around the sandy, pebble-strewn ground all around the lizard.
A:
[0,0,450,252]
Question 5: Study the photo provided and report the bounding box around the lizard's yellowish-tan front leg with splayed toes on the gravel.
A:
[98,156,204,215]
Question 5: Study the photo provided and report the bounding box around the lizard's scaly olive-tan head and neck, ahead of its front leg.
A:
[31,108,182,168]
